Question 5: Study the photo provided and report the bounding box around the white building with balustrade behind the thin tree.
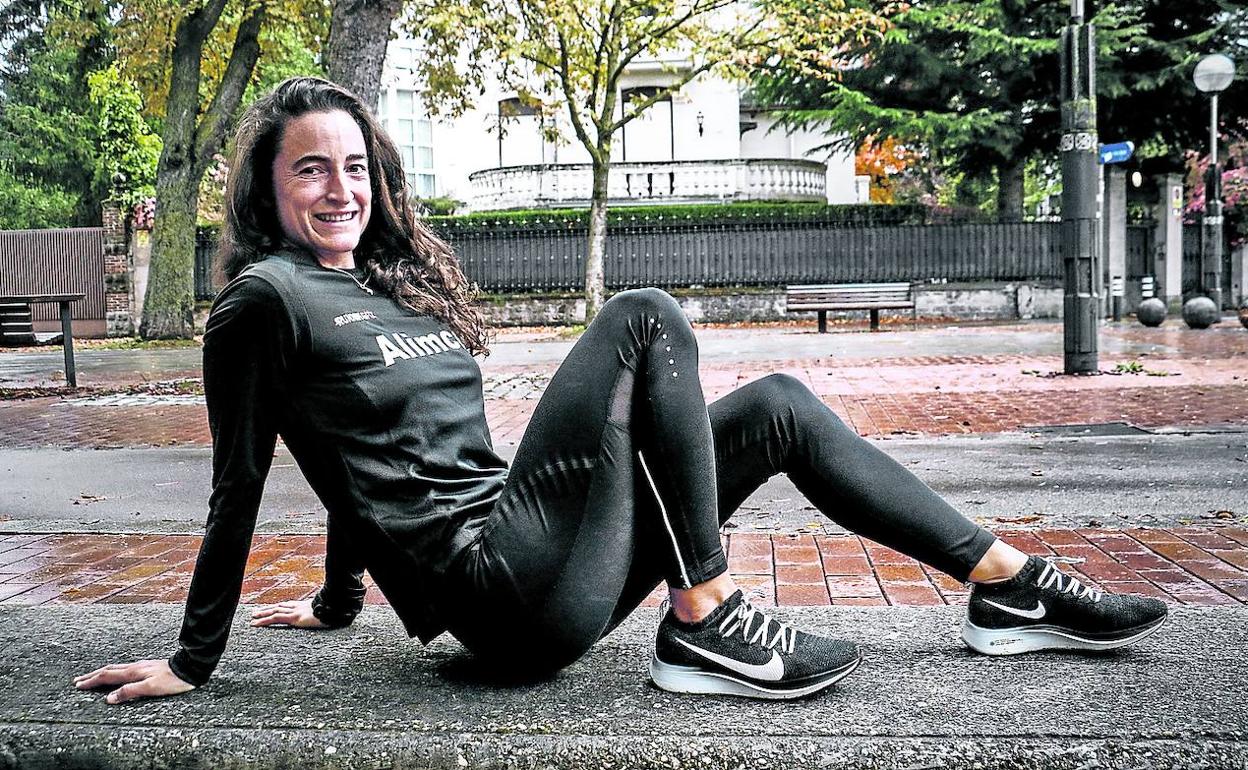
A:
[378,37,861,211]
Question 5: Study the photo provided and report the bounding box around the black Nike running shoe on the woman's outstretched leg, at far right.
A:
[962,557,1167,655]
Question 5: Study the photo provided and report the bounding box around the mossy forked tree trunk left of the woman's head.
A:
[139,0,263,339]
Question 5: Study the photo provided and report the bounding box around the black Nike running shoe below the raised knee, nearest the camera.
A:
[650,592,862,699]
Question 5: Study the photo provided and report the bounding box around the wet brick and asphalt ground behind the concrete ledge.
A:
[0,315,1248,604]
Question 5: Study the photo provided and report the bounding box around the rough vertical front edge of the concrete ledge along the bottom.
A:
[0,725,1248,770]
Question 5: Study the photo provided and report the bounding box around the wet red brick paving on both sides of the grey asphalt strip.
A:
[0,327,1248,616]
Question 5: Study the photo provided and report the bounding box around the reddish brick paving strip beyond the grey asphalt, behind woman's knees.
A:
[7,356,1248,448]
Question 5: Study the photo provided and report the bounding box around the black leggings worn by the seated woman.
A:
[439,290,995,669]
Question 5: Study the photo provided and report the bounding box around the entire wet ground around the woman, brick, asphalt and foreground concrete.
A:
[0,315,1248,770]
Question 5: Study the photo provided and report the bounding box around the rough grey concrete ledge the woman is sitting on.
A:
[0,605,1248,770]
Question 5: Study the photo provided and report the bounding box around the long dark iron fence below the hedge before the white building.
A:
[196,221,1062,298]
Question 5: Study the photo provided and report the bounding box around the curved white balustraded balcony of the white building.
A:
[468,158,827,211]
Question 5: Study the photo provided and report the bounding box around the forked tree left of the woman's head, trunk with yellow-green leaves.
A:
[117,0,326,339]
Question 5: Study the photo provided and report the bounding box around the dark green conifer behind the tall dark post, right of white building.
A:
[755,0,1141,218]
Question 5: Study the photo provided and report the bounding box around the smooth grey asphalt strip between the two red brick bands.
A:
[0,432,1248,533]
